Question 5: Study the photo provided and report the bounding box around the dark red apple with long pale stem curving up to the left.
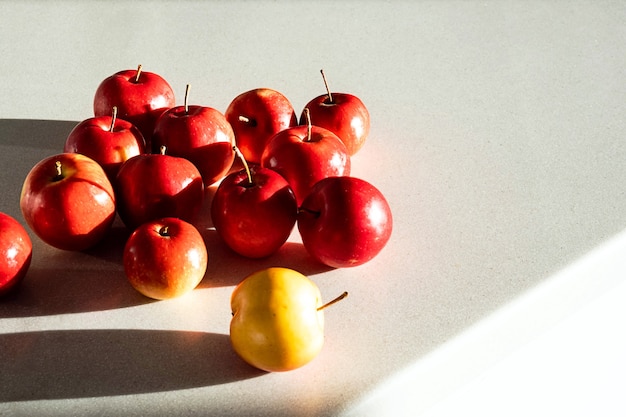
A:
[211,165,298,258]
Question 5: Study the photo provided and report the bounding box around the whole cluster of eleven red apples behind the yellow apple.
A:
[0,66,392,299]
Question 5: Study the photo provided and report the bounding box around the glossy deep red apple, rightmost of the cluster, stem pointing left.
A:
[297,177,393,268]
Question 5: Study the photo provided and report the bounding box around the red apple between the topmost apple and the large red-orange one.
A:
[63,107,146,180]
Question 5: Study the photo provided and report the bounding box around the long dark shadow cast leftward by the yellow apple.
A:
[0,329,265,402]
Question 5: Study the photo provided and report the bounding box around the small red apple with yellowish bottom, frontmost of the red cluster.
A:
[123,217,208,300]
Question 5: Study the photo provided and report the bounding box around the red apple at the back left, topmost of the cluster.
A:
[93,65,176,149]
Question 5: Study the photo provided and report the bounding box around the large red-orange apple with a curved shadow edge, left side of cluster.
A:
[20,153,116,251]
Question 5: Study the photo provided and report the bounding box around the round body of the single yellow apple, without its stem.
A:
[230,267,324,372]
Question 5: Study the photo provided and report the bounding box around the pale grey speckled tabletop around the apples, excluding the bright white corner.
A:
[0,1,626,416]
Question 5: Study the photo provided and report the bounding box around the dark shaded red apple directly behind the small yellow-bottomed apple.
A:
[115,154,204,230]
